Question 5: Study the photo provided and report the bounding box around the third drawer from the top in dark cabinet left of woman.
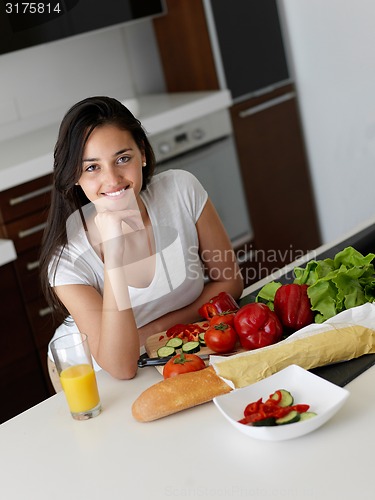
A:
[14,246,42,302]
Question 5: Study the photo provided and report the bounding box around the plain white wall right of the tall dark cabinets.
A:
[279,0,375,242]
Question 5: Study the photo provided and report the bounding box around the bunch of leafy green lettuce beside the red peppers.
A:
[293,247,375,323]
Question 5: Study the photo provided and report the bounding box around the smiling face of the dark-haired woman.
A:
[78,125,145,205]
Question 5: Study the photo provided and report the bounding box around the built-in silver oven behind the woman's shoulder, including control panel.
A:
[150,108,252,249]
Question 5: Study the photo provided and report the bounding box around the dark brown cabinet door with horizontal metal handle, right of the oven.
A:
[231,85,320,277]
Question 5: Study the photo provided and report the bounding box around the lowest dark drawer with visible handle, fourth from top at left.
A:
[26,297,58,350]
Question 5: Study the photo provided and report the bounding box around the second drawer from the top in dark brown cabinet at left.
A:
[0,209,47,254]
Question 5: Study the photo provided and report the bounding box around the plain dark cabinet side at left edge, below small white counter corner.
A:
[0,262,49,423]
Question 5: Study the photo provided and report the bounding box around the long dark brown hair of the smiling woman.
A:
[39,96,155,322]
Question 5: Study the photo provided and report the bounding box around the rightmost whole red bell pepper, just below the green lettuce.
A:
[274,283,314,331]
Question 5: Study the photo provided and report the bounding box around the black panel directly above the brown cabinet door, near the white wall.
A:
[208,0,289,99]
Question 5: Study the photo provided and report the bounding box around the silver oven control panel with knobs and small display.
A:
[149,109,232,163]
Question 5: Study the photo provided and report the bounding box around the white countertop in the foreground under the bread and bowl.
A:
[0,367,375,500]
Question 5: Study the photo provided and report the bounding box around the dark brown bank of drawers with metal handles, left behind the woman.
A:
[0,175,56,397]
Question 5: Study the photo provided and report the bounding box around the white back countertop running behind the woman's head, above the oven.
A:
[0,90,232,191]
